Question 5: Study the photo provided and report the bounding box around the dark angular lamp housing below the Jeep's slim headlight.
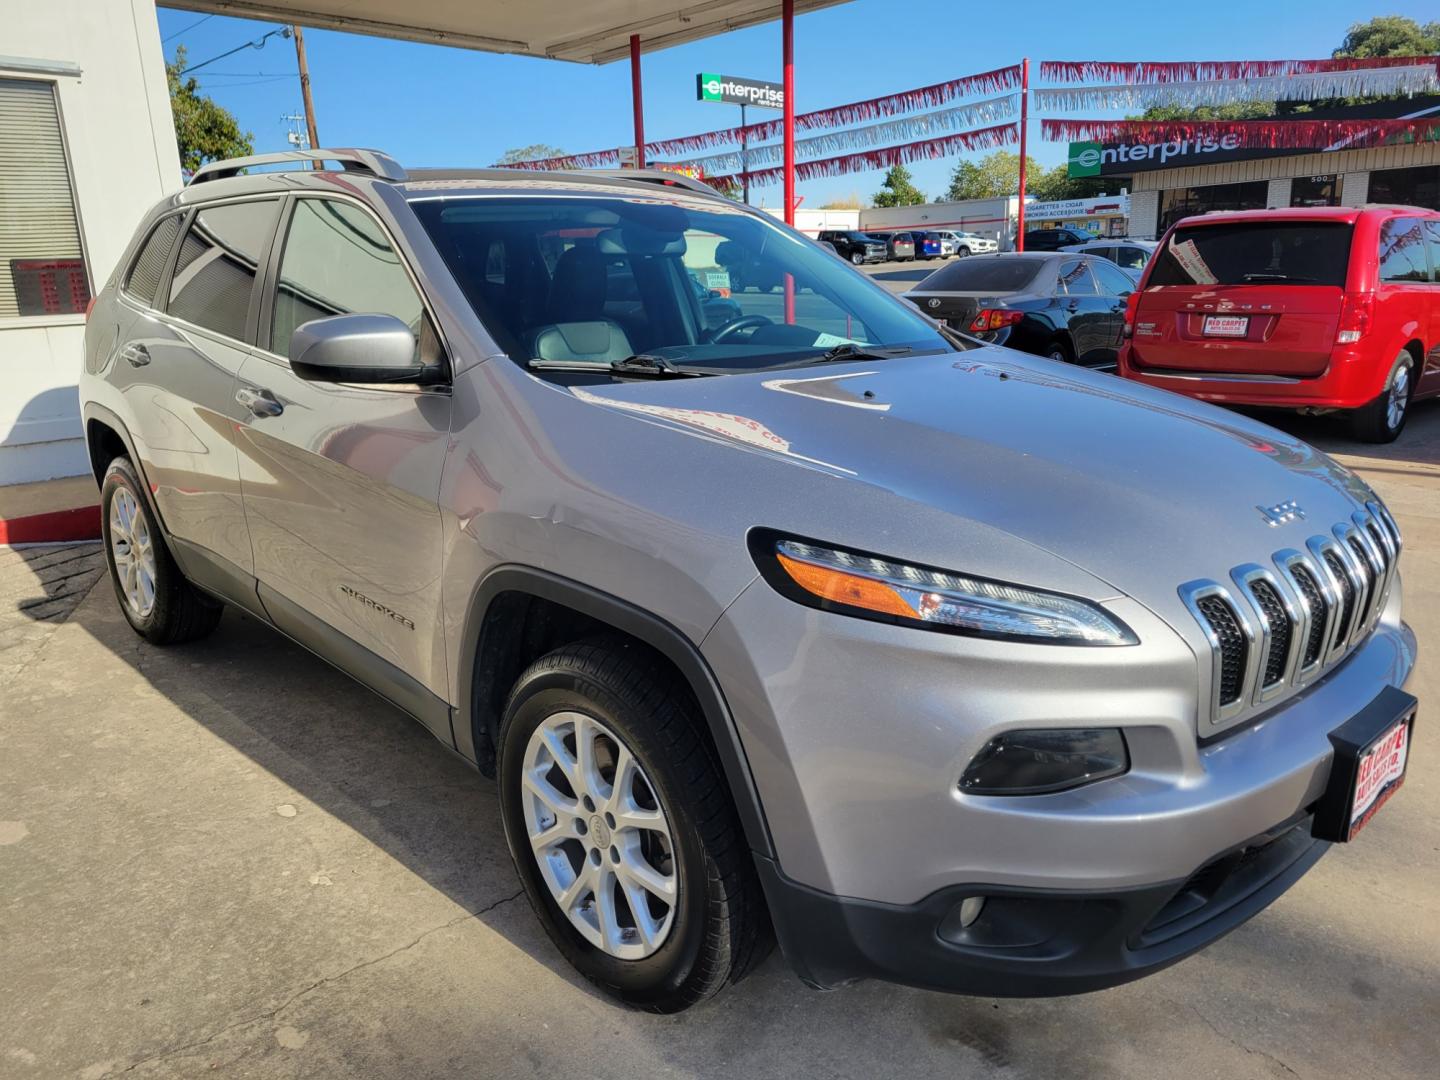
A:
[960,727,1130,795]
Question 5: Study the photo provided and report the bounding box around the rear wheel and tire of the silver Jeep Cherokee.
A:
[99,458,225,645]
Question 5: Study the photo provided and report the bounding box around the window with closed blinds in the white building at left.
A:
[0,79,91,318]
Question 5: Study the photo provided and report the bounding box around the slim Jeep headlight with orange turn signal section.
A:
[750,530,1139,645]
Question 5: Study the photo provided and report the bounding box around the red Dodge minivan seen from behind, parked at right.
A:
[1119,206,1440,442]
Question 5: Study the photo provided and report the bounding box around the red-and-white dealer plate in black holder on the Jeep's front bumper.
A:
[1312,687,1416,842]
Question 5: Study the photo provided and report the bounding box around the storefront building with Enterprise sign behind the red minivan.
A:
[1070,96,1440,239]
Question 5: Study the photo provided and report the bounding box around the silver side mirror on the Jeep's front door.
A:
[289,315,439,384]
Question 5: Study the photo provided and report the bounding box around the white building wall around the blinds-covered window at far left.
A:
[0,0,180,484]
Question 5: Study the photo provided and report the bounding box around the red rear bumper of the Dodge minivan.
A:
[1117,341,1388,409]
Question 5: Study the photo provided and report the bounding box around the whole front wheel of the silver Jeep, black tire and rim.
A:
[498,639,768,1012]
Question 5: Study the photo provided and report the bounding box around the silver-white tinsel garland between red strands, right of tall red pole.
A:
[1031,63,1440,112]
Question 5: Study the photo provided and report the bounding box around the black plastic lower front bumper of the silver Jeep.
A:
[756,818,1329,998]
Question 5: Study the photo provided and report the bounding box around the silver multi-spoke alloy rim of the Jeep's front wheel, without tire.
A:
[520,711,678,960]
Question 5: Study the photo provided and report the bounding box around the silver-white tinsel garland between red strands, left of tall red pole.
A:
[505,63,1020,168]
